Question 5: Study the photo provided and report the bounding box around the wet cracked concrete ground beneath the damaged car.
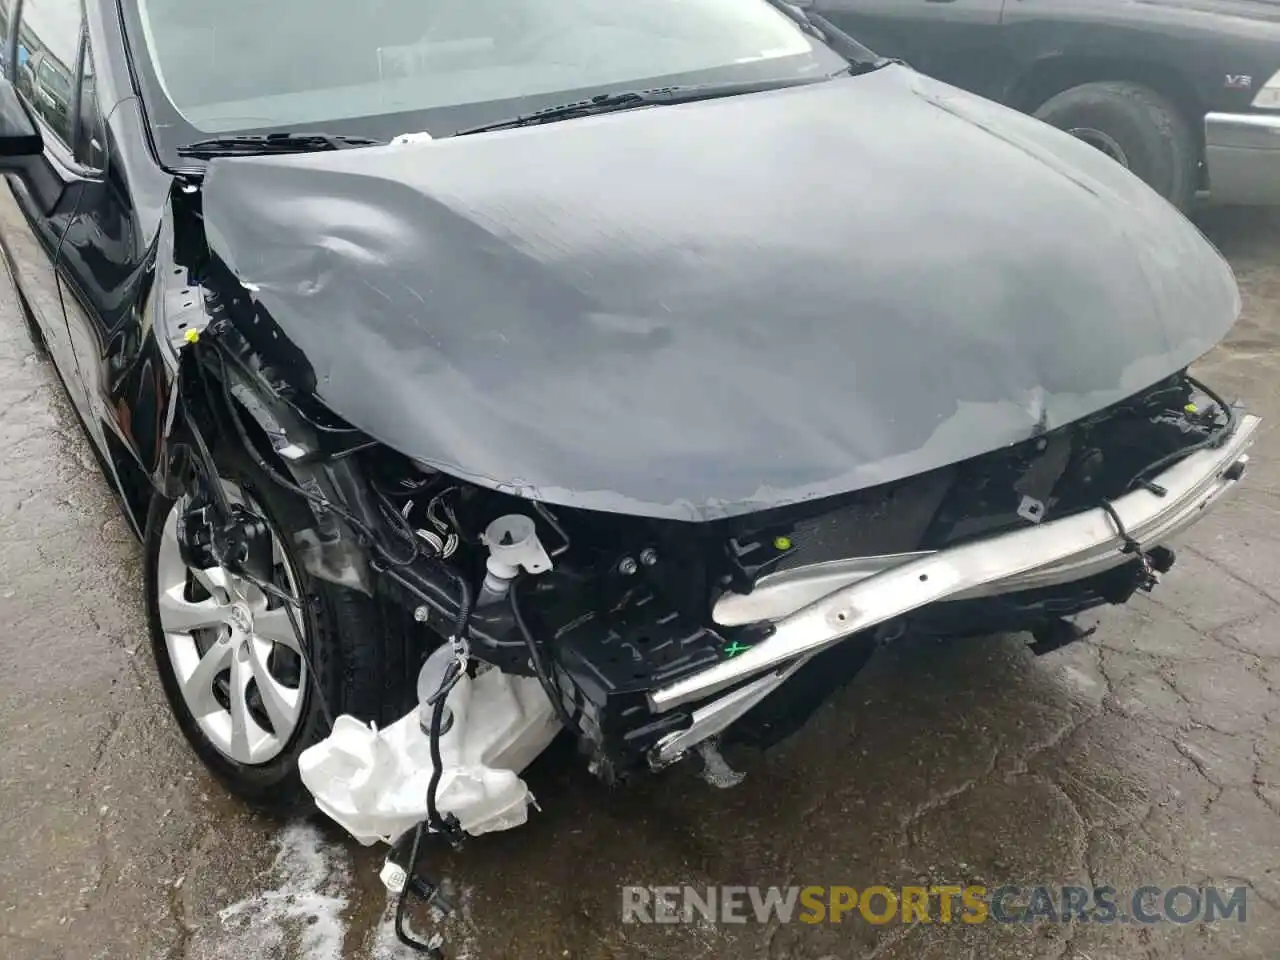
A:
[0,211,1280,960]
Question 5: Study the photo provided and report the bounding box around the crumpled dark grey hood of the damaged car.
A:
[204,67,1239,520]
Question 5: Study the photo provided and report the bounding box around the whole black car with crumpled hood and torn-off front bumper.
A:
[0,0,1258,911]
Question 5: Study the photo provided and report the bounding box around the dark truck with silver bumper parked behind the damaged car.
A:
[797,0,1280,209]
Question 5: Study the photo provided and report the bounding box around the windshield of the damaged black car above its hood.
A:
[124,0,846,161]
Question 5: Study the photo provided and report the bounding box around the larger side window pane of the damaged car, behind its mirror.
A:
[15,0,82,151]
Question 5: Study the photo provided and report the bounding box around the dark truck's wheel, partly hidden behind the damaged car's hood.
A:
[1036,82,1199,210]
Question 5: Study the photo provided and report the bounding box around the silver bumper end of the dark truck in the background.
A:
[1204,114,1280,205]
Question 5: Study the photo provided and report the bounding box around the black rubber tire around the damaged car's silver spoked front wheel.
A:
[143,442,425,814]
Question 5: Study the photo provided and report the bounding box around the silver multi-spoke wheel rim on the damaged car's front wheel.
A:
[156,481,307,765]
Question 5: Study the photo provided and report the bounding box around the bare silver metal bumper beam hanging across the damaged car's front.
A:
[649,416,1261,721]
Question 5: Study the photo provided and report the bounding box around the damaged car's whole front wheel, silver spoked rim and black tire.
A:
[145,453,425,813]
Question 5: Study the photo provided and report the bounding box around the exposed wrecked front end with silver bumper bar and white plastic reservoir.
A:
[145,224,1258,956]
